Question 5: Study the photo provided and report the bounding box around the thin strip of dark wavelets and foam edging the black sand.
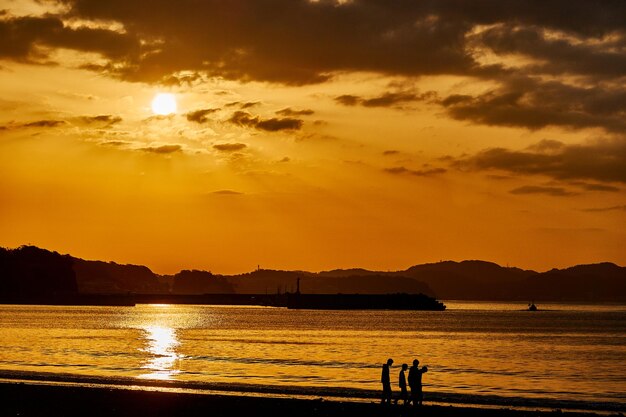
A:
[0,370,626,415]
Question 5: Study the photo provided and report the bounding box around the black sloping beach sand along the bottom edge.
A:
[0,382,616,417]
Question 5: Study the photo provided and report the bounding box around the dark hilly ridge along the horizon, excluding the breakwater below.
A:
[0,246,626,302]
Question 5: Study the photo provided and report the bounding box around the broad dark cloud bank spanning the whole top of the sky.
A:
[0,0,626,93]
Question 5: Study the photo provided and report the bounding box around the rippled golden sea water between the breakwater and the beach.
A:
[0,301,626,409]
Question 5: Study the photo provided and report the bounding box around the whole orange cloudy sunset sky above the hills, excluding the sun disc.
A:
[0,0,626,273]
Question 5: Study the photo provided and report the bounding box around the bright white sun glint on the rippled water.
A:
[139,326,181,379]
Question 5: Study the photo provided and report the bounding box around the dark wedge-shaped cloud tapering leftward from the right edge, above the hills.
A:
[452,138,626,183]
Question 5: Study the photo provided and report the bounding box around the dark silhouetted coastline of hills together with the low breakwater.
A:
[0,246,626,309]
